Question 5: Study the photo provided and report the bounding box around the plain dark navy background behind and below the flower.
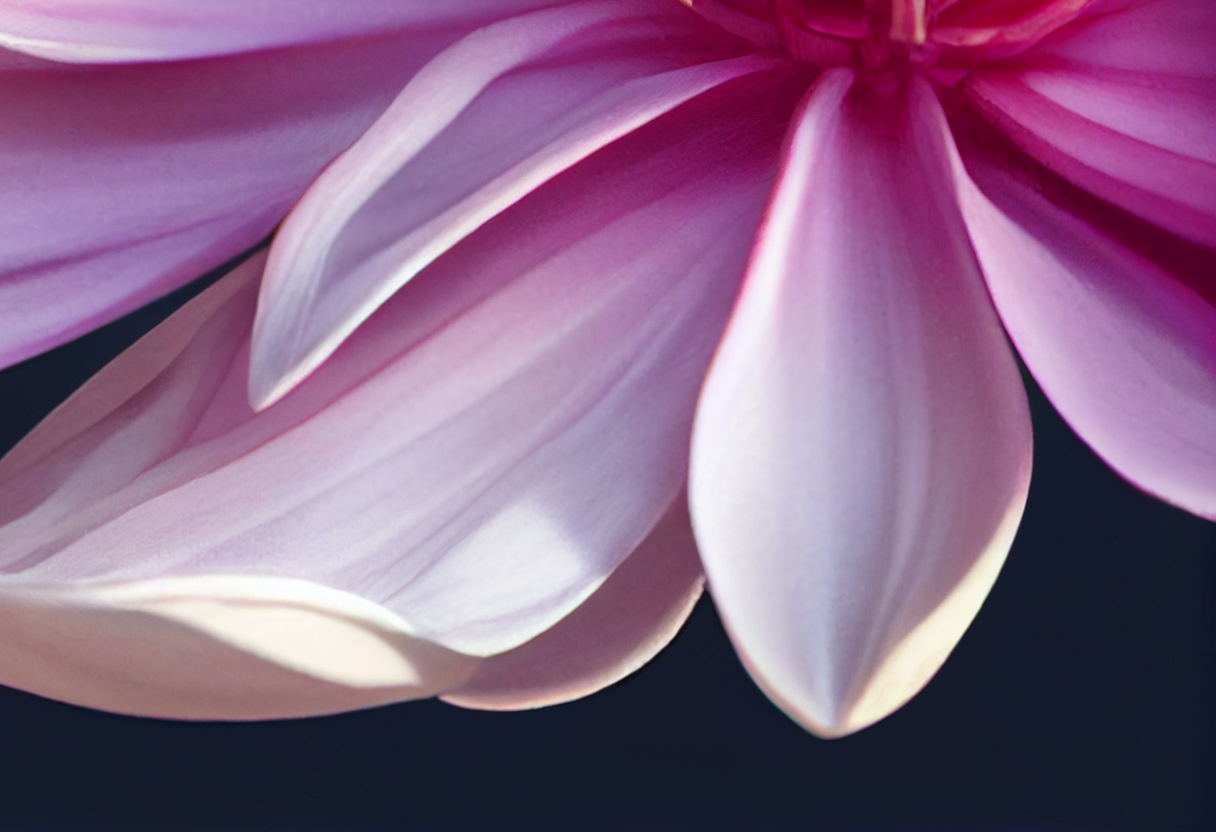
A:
[0,267,1216,832]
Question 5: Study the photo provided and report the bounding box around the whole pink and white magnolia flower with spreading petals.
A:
[0,0,1216,736]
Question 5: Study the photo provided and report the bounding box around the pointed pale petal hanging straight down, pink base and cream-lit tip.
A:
[689,69,1031,736]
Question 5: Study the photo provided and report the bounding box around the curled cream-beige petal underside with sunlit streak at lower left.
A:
[0,578,479,719]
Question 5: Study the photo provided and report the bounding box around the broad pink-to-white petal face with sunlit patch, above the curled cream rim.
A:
[0,78,792,676]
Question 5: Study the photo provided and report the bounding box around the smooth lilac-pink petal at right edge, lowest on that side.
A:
[956,150,1216,518]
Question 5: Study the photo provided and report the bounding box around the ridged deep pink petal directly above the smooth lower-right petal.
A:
[966,69,1216,246]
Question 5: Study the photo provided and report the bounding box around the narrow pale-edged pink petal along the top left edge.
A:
[0,0,556,63]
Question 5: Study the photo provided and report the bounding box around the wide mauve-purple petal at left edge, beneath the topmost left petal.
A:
[0,33,452,366]
